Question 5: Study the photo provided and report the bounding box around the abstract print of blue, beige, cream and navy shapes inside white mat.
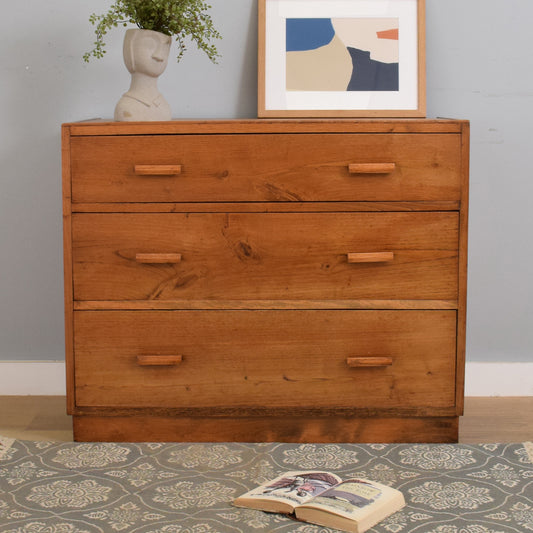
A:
[286,18,399,91]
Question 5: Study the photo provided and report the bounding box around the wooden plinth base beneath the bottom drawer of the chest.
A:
[73,416,458,442]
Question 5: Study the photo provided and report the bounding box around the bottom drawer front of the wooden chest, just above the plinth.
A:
[74,311,456,409]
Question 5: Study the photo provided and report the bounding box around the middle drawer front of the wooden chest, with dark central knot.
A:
[72,212,458,300]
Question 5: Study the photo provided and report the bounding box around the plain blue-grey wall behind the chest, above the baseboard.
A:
[0,0,533,361]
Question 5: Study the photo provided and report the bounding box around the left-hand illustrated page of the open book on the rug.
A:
[239,471,341,507]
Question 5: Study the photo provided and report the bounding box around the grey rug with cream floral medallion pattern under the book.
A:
[0,437,533,533]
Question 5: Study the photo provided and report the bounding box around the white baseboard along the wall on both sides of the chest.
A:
[0,361,533,396]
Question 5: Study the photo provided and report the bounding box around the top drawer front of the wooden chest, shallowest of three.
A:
[71,134,461,202]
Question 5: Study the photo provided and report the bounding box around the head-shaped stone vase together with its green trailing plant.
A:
[83,0,220,121]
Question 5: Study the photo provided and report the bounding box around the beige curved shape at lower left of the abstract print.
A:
[286,36,353,91]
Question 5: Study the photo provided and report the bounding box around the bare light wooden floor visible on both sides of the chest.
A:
[0,396,533,443]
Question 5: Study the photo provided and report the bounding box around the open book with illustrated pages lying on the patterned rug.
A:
[233,470,405,533]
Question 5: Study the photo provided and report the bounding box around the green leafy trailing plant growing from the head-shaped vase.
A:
[83,0,220,63]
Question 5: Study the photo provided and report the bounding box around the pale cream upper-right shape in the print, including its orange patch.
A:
[331,18,399,63]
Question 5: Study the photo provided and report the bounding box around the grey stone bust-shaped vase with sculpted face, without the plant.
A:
[115,29,172,121]
